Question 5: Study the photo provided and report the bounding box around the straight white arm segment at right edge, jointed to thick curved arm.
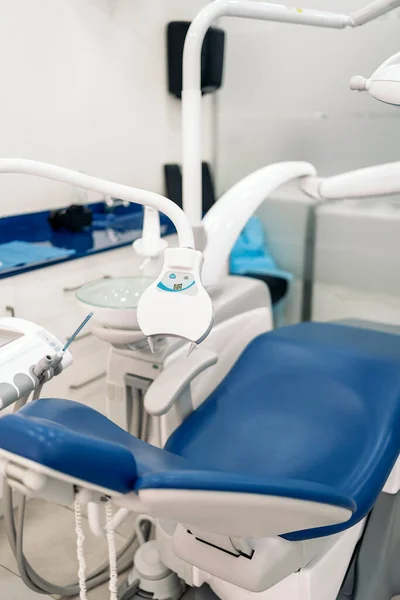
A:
[300,162,400,200]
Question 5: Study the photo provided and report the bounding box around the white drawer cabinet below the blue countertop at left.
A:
[0,246,140,412]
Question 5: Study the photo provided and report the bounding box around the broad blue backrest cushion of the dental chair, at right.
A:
[166,323,400,540]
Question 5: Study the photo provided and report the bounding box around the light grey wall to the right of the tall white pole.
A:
[217,0,400,193]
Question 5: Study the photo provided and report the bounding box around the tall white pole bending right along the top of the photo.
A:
[182,0,400,225]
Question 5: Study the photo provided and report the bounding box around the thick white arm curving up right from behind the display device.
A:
[203,162,316,286]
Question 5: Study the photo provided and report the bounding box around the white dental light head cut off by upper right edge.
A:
[350,52,400,105]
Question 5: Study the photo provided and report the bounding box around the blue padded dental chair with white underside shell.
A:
[0,323,400,591]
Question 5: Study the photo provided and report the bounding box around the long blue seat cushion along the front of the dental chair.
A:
[0,398,356,511]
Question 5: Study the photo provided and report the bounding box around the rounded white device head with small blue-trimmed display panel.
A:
[137,248,214,344]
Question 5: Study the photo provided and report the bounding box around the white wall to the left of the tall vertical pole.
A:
[0,0,213,215]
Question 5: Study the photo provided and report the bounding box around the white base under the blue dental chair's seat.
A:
[156,520,368,600]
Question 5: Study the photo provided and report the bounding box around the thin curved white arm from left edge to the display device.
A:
[0,158,194,248]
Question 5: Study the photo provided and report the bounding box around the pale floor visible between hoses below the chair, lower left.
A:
[0,500,138,600]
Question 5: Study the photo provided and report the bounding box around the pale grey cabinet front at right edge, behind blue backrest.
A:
[312,198,400,325]
